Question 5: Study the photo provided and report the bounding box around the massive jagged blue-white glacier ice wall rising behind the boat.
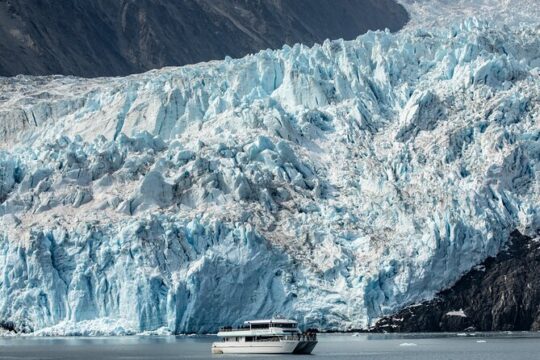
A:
[0,20,540,334]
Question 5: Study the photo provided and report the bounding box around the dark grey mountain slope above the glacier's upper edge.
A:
[0,0,408,77]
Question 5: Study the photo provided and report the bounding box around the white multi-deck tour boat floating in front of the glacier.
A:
[212,319,317,354]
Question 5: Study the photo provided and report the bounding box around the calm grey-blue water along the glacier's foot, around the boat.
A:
[0,333,540,360]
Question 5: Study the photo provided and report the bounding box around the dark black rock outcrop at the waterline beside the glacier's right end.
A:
[373,231,540,332]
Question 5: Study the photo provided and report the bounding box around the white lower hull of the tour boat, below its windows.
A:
[212,341,300,354]
